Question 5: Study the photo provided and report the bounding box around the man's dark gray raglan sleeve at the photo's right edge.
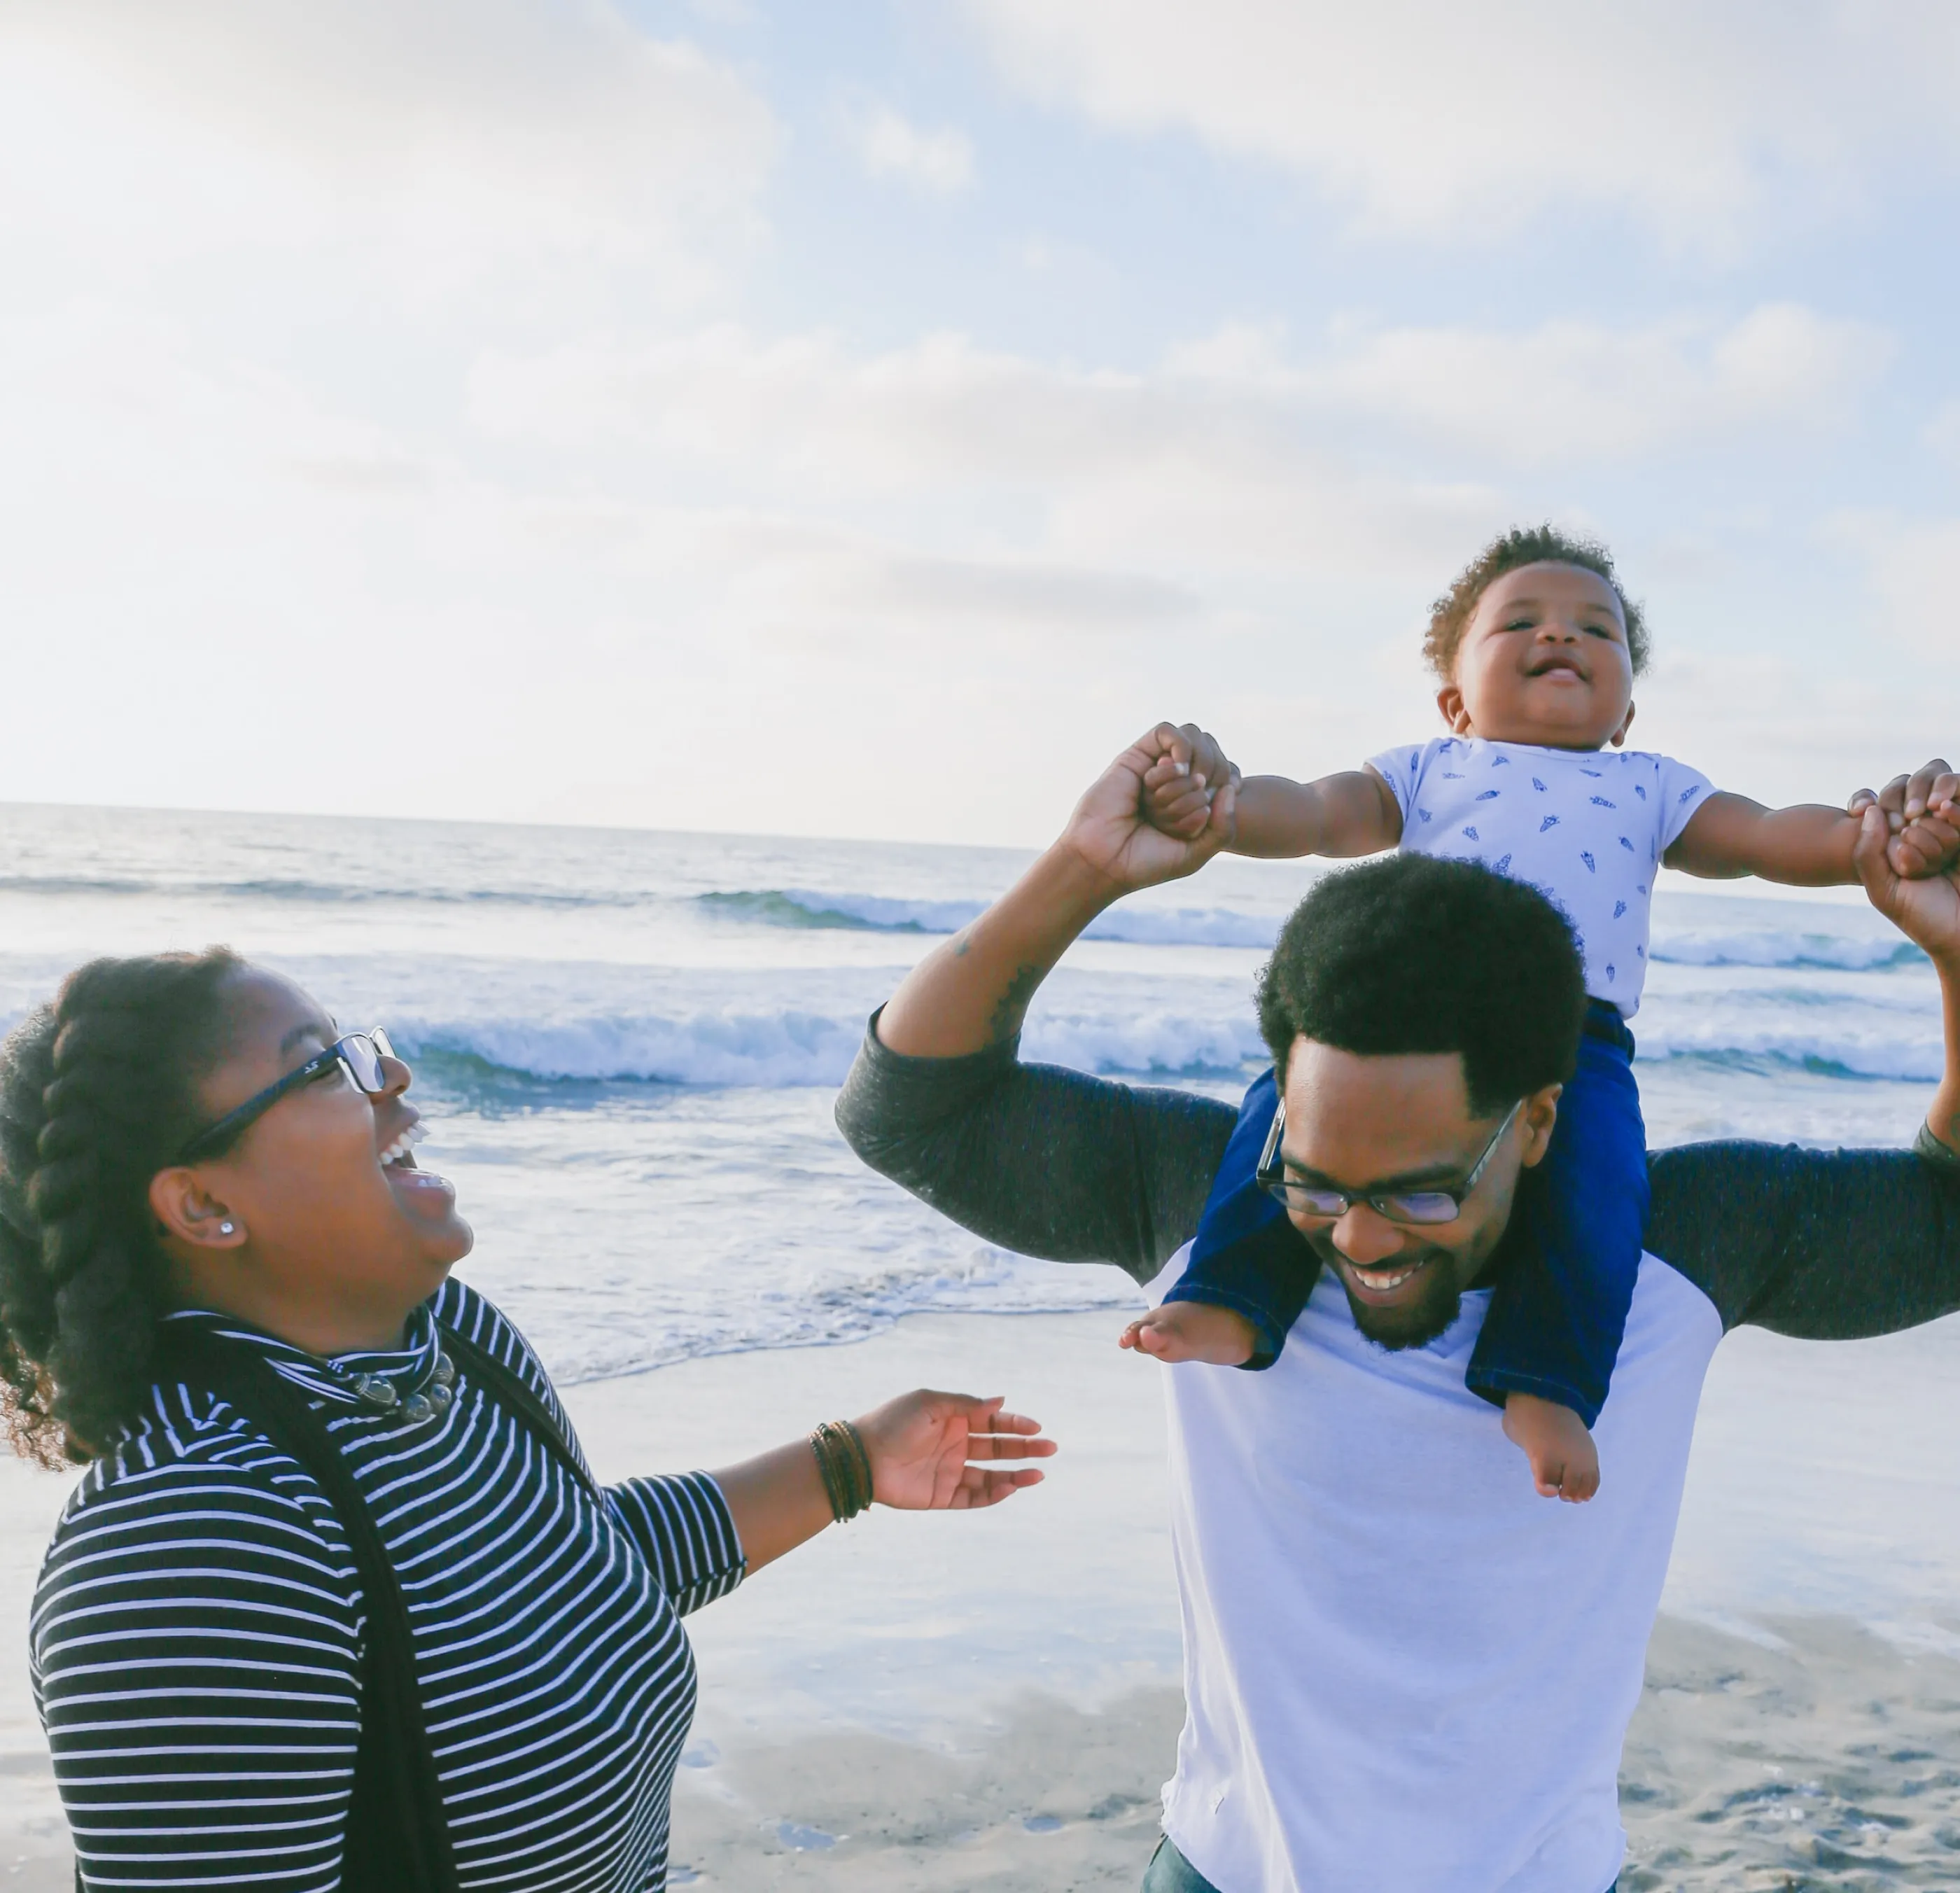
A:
[1646,1135,1960,1341]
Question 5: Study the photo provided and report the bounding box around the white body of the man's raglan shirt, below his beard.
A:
[1151,1244,1721,1893]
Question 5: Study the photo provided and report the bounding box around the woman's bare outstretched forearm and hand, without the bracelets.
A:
[713,1388,1054,1576]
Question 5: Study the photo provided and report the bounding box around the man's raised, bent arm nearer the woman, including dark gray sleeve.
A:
[837,736,1233,1282]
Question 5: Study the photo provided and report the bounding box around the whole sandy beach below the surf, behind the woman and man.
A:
[0,1315,1960,1893]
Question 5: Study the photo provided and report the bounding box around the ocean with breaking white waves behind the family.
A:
[0,807,1938,1381]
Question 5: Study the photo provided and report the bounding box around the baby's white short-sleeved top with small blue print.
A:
[1368,736,1715,1019]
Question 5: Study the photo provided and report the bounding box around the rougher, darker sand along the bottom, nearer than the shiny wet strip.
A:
[674,1619,1960,1893]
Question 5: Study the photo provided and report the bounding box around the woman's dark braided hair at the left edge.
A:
[0,946,243,1466]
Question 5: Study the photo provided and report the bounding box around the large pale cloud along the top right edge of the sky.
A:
[965,0,1960,245]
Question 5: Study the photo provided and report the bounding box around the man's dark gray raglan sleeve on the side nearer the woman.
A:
[837,1015,1237,1282]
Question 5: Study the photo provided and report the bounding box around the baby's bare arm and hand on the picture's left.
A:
[1144,723,1401,860]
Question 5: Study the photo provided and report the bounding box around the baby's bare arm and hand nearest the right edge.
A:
[1666,762,1960,888]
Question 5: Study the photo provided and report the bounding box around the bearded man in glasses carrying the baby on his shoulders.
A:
[837,743,1960,1893]
